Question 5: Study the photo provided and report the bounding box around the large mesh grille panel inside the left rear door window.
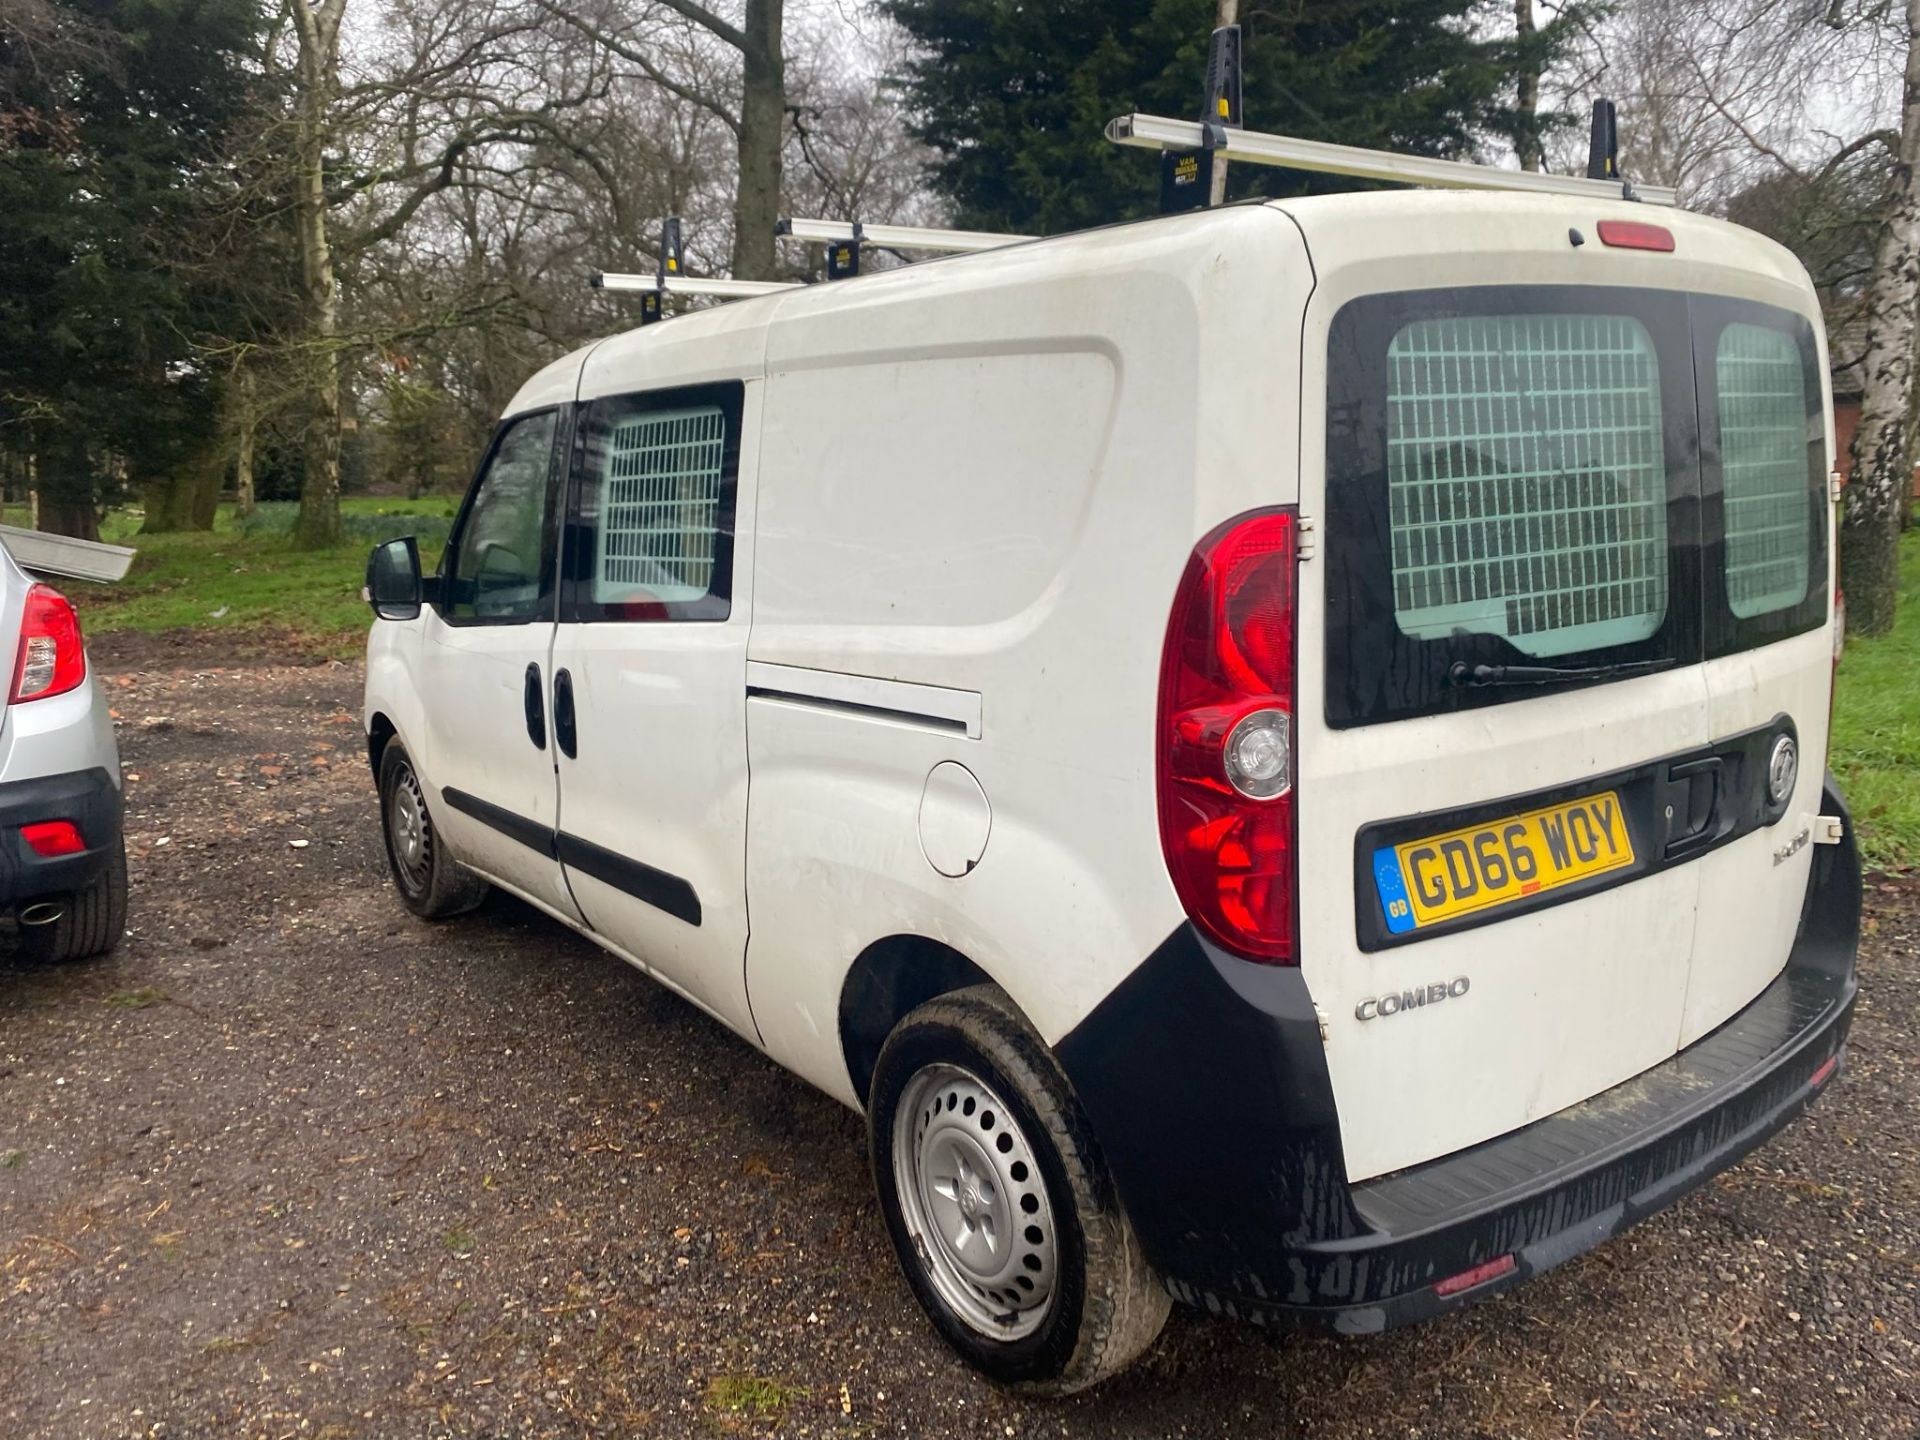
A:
[1386,315,1667,655]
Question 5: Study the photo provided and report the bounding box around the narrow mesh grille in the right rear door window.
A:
[1713,324,1812,618]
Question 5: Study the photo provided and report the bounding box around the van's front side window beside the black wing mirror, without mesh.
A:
[442,411,559,624]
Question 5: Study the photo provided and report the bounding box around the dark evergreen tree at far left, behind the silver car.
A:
[0,0,261,536]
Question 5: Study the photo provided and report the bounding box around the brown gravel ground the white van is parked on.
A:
[0,647,1920,1440]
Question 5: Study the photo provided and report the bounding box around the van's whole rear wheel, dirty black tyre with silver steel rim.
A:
[868,985,1169,1394]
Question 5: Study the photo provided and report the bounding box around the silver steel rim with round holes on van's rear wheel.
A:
[893,1064,1060,1340]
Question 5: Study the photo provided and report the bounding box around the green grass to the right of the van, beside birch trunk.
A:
[1828,530,1920,870]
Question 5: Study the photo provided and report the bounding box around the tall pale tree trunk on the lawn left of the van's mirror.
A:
[294,0,347,549]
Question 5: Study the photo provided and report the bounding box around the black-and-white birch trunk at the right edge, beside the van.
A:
[1839,0,1920,636]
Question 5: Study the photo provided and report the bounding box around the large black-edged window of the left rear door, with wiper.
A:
[1327,286,1703,726]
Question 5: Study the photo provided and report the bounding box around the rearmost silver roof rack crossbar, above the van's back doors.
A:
[1106,115,1676,205]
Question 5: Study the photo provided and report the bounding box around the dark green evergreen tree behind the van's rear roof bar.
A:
[885,0,1569,234]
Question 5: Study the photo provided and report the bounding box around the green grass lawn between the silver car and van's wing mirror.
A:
[69,495,459,657]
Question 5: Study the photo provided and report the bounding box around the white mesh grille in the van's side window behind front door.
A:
[593,405,726,603]
